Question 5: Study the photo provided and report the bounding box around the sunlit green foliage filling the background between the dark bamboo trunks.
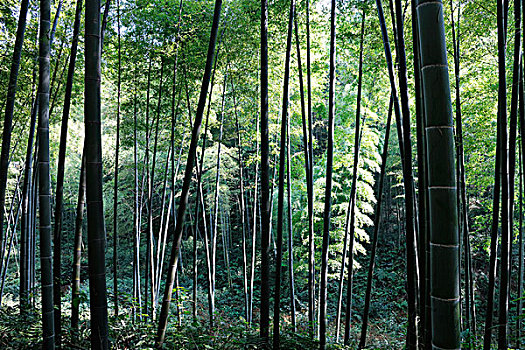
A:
[0,0,525,349]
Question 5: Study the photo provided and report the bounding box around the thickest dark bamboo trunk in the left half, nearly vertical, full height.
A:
[84,0,109,349]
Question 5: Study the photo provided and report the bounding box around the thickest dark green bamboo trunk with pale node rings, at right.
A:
[417,0,460,349]
